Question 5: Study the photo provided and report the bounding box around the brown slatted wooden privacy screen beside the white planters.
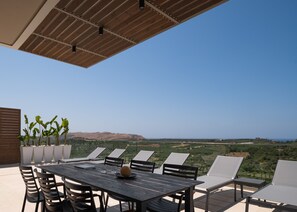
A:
[0,107,21,164]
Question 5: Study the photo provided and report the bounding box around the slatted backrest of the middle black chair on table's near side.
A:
[34,169,63,212]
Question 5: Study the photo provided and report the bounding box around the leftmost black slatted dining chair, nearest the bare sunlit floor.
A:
[19,166,44,212]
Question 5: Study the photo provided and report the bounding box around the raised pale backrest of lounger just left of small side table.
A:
[207,155,243,179]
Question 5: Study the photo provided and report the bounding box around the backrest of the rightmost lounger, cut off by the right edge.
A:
[272,160,297,187]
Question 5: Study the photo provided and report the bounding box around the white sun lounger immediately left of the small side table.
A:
[195,155,243,211]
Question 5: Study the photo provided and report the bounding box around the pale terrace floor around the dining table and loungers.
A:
[0,165,275,212]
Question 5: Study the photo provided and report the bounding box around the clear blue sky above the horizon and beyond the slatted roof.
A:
[0,0,297,139]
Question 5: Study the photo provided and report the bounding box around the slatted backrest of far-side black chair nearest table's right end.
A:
[163,164,198,180]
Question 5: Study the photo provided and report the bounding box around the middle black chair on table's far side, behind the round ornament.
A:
[106,160,155,212]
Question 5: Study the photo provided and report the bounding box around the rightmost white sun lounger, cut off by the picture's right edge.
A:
[246,160,297,211]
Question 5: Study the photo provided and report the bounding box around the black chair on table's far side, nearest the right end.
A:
[147,164,198,212]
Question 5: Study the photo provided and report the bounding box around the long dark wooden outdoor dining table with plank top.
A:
[39,162,203,212]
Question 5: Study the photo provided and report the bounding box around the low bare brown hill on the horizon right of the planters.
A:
[68,132,144,141]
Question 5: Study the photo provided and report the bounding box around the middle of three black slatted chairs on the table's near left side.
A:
[34,169,73,212]
